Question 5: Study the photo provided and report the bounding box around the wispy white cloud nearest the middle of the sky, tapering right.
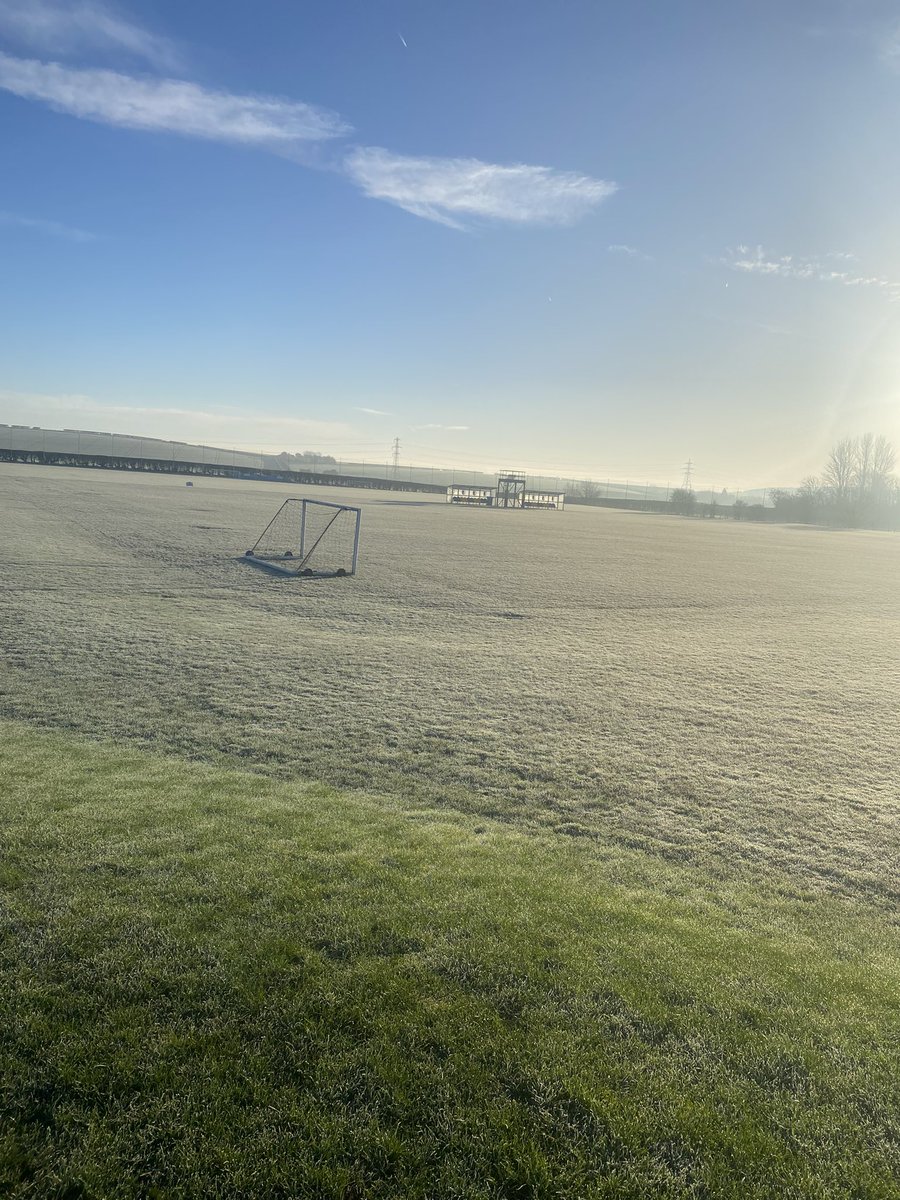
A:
[344,146,616,229]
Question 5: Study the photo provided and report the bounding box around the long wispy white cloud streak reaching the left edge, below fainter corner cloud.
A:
[0,52,348,150]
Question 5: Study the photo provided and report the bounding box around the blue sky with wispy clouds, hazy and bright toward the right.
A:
[0,0,900,487]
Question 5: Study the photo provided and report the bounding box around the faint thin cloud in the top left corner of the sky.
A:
[0,0,181,71]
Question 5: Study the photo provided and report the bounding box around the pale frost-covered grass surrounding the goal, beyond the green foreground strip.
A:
[0,467,900,907]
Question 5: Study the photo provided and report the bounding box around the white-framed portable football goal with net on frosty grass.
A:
[244,499,361,578]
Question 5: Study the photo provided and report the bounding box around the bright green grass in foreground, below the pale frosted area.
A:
[0,724,900,1200]
